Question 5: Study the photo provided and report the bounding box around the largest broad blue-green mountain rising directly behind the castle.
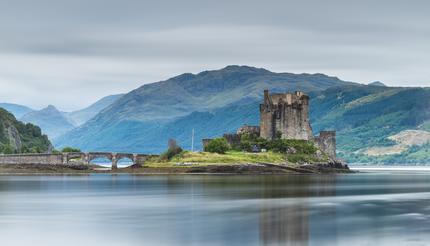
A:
[55,66,430,163]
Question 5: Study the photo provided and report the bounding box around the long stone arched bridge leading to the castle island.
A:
[0,152,153,169]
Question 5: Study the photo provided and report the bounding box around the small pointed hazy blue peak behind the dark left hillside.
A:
[20,105,75,139]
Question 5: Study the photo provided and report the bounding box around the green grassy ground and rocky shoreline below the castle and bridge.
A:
[0,151,352,175]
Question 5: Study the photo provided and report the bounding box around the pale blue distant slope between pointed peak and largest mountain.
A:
[67,94,124,126]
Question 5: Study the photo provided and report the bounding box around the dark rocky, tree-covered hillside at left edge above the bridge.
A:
[0,108,52,154]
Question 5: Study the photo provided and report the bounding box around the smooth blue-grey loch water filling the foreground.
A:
[0,171,430,246]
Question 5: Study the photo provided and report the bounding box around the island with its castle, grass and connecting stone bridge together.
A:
[0,90,350,174]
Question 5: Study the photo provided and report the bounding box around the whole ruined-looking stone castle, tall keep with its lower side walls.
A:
[203,90,336,159]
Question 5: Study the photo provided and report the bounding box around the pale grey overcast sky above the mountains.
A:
[0,0,430,110]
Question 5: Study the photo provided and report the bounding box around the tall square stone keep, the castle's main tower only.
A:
[260,90,313,140]
